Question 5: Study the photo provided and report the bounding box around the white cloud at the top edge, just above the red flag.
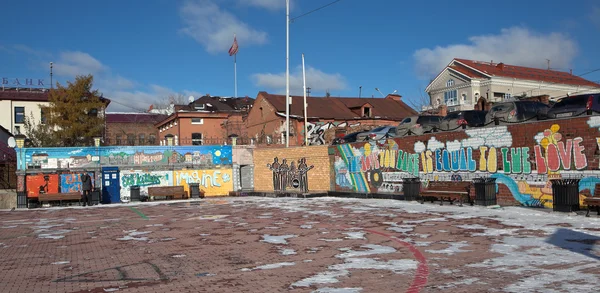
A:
[179,0,267,53]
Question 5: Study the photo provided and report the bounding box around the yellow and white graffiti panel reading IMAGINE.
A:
[173,169,233,196]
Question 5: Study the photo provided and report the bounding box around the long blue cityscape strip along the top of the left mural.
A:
[17,145,232,170]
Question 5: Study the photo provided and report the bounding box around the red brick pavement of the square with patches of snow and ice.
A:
[0,198,600,292]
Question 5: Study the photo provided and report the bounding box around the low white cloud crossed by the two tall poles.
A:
[252,66,347,95]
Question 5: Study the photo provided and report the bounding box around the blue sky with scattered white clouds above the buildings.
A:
[0,0,600,111]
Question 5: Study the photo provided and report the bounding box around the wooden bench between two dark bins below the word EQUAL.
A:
[420,181,473,206]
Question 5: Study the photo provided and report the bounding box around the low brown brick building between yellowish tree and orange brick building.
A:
[104,113,167,145]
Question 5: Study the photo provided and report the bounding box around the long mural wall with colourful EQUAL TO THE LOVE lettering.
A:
[334,116,600,207]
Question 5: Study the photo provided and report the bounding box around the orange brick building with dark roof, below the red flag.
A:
[155,95,254,145]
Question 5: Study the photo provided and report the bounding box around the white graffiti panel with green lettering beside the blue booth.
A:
[119,170,173,202]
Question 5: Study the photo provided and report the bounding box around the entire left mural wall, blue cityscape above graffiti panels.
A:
[17,145,237,202]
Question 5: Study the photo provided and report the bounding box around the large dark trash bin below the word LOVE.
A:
[550,179,579,212]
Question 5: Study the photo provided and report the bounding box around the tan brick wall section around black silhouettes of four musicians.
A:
[254,146,331,191]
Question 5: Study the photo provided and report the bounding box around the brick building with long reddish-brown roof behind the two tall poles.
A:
[246,92,417,145]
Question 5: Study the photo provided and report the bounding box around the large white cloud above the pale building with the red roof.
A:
[413,27,576,78]
